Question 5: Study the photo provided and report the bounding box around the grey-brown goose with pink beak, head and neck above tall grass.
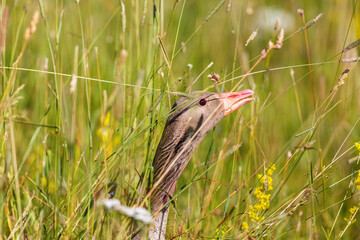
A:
[133,90,254,240]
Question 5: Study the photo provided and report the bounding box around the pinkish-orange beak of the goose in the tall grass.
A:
[218,89,254,116]
